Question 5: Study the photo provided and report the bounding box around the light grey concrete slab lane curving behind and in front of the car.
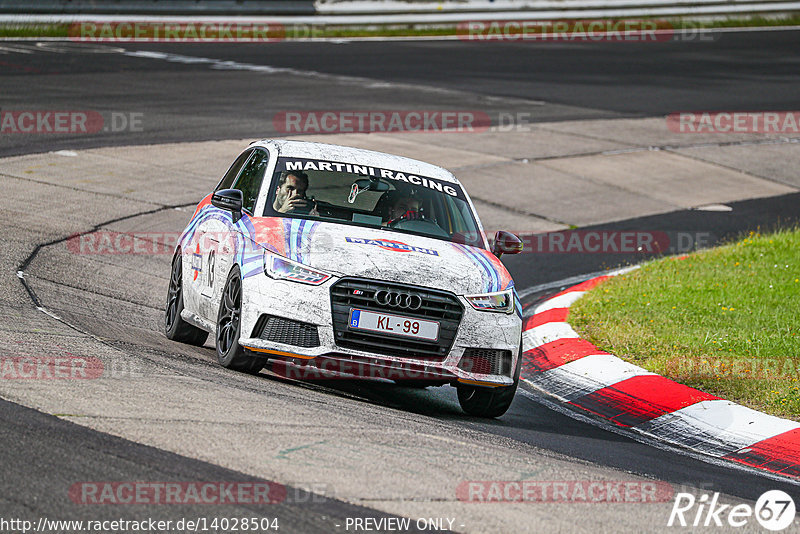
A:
[0,119,800,532]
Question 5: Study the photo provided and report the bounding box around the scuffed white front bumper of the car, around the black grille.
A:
[239,274,522,386]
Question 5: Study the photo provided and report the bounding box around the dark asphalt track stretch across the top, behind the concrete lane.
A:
[0,31,800,155]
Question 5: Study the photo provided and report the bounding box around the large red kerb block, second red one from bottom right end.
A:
[571,375,719,427]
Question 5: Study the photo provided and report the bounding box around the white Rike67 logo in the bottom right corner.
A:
[667,490,796,532]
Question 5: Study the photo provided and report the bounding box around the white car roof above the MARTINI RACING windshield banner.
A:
[250,139,459,184]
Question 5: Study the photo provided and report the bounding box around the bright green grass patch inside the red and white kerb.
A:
[569,228,800,420]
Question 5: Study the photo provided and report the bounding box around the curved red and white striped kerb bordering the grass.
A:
[521,273,800,478]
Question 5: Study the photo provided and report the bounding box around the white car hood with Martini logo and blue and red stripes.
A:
[258,219,512,295]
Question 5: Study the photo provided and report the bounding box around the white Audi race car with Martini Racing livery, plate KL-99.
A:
[164,140,522,417]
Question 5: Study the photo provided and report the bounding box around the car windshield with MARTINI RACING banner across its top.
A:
[264,157,484,248]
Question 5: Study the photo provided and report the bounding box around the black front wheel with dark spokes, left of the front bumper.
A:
[215,266,266,374]
